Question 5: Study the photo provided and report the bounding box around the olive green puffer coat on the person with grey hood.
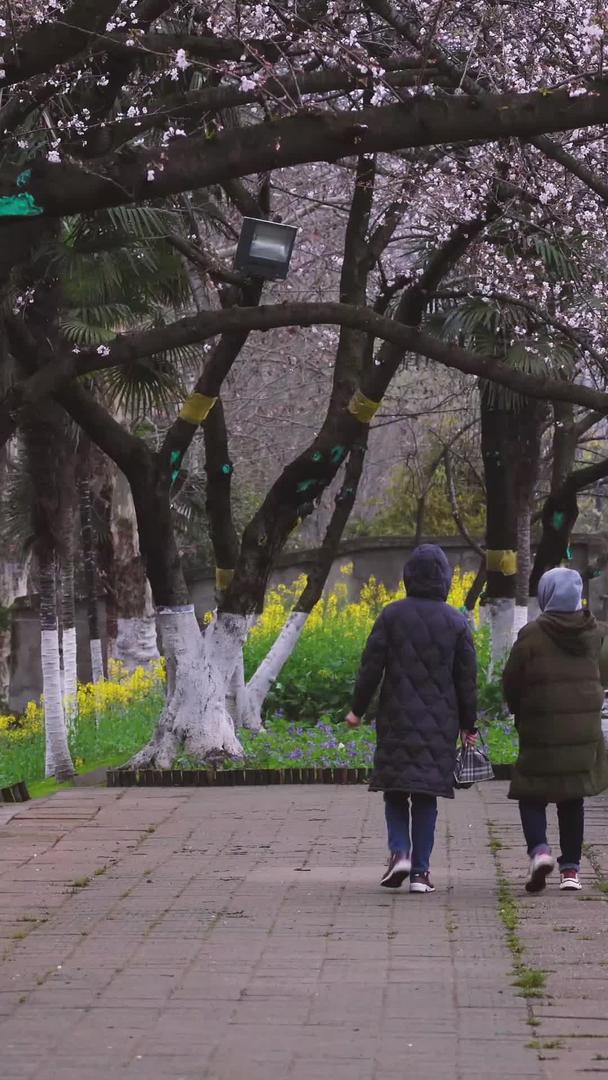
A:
[503,611,608,802]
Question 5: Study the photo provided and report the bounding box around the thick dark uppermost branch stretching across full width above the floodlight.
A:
[1,87,608,221]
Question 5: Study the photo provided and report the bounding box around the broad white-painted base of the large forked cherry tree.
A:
[132,606,247,768]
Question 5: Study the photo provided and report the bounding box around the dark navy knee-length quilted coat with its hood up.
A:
[352,544,476,798]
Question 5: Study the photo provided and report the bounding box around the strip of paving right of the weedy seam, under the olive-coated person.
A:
[482,784,608,1080]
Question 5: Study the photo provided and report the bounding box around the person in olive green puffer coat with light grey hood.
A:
[503,567,608,892]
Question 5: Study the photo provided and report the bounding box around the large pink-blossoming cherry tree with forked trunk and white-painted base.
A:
[0,0,608,764]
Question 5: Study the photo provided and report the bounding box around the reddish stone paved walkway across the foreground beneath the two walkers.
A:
[0,784,608,1080]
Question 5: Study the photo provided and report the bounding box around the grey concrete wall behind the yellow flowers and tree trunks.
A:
[10,536,608,712]
